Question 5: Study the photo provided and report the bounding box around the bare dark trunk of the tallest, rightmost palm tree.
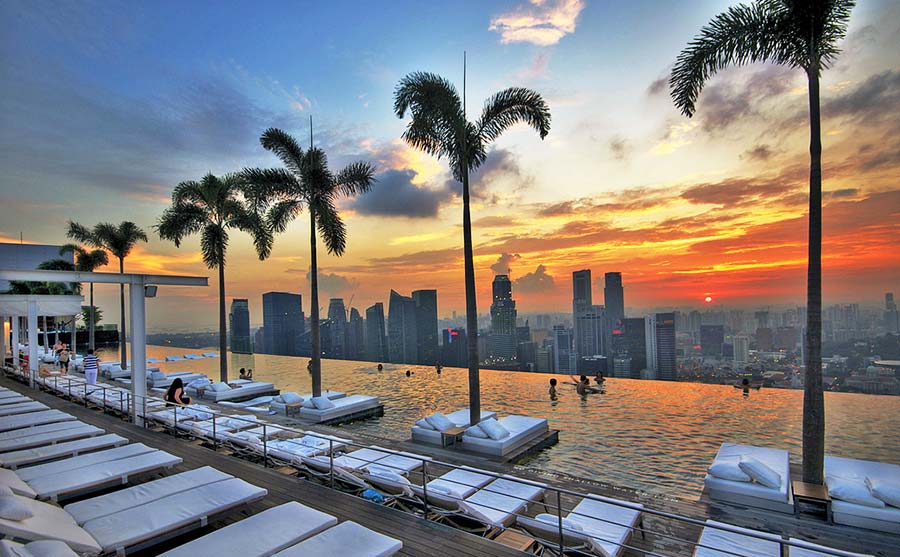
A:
[803,66,825,484]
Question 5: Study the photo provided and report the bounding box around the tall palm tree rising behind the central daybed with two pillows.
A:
[394,72,550,424]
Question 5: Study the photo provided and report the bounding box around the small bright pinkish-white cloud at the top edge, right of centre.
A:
[488,0,584,46]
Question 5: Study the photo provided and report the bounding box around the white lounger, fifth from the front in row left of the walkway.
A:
[28,451,182,501]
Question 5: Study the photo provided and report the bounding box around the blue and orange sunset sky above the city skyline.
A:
[0,0,900,328]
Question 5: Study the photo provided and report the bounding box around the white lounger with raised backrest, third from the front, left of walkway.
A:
[0,478,266,555]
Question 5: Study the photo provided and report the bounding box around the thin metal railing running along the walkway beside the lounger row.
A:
[4,367,868,557]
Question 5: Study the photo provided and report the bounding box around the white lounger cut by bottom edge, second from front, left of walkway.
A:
[160,501,337,557]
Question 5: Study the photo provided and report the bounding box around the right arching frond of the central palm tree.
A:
[475,87,550,143]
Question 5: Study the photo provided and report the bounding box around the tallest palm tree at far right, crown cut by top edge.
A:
[669,0,855,484]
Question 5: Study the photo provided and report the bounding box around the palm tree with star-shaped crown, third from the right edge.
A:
[243,128,375,396]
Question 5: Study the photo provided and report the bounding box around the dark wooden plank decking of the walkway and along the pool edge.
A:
[0,378,900,557]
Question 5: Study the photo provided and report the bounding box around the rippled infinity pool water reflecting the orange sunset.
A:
[112,346,900,498]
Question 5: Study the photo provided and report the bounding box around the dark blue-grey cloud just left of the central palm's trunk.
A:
[348,169,453,219]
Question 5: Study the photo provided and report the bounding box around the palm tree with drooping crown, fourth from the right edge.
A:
[154,174,272,381]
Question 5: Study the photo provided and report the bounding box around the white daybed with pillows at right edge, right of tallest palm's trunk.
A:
[825,456,900,534]
